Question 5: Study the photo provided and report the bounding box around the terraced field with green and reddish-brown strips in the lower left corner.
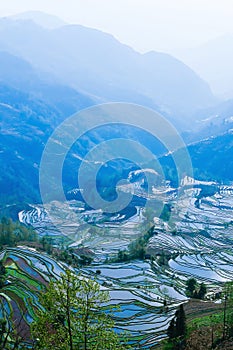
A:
[0,248,63,340]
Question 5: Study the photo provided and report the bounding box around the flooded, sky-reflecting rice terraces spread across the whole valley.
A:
[14,183,233,349]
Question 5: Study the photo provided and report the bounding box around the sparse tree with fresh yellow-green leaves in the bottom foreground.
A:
[31,270,129,350]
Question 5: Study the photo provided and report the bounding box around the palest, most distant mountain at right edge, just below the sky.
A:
[176,35,233,98]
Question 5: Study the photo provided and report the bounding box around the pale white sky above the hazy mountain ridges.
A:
[0,0,233,53]
